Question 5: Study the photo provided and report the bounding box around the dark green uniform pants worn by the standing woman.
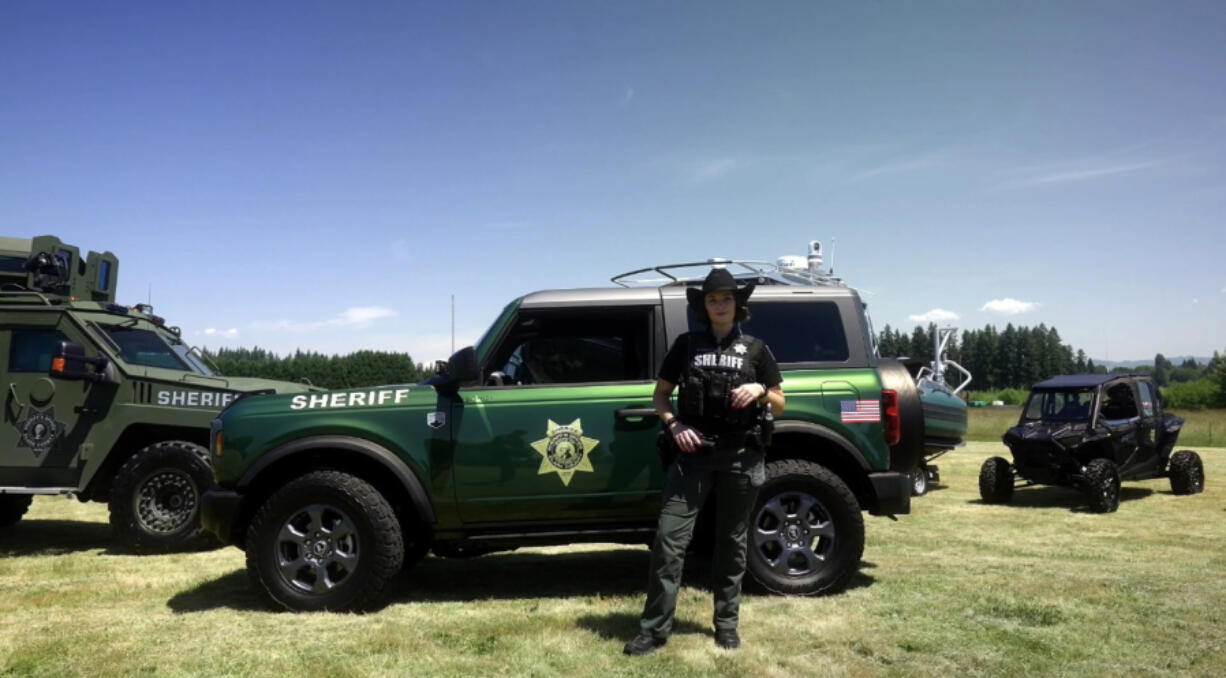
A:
[640,449,764,638]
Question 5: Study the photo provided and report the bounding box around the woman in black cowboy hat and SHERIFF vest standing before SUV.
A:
[625,269,783,655]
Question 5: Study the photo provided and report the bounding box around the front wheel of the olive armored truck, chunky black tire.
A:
[110,440,217,553]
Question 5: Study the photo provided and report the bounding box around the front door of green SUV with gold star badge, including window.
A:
[452,303,663,526]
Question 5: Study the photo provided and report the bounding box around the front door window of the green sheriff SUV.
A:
[492,309,651,385]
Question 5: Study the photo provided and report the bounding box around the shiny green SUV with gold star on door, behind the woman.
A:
[204,243,966,611]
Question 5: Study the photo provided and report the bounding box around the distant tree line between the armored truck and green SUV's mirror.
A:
[204,347,434,389]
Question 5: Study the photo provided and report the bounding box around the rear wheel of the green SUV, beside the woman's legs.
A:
[747,460,864,596]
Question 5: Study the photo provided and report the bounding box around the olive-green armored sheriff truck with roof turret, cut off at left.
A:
[0,235,308,552]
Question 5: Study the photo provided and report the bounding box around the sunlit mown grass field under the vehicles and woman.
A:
[0,443,1226,678]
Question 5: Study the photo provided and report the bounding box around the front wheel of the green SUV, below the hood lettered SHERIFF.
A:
[246,471,405,612]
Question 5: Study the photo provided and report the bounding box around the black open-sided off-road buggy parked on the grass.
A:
[980,374,1205,512]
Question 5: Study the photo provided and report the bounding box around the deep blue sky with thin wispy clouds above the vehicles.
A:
[0,0,1226,362]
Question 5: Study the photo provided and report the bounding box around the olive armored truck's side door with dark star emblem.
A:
[0,311,106,488]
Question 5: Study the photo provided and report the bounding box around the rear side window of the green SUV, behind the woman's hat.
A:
[689,299,848,363]
